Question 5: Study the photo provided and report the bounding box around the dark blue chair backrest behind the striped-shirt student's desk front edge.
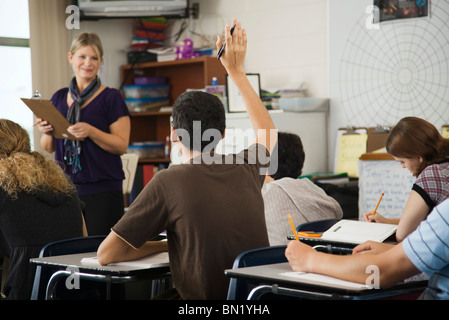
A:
[227,245,287,300]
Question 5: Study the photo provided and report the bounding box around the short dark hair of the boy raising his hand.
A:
[173,91,226,151]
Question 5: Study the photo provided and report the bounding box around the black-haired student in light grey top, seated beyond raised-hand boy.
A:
[262,132,343,246]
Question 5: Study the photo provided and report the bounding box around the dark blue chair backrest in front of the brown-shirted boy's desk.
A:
[31,236,106,300]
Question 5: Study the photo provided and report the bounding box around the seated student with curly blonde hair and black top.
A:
[0,119,87,300]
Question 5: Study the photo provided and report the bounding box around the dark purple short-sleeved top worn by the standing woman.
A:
[51,88,130,196]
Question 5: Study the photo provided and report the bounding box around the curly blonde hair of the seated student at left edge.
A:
[0,119,76,199]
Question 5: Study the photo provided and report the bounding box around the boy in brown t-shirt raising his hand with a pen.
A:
[97,21,276,299]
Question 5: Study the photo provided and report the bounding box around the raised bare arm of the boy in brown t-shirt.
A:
[217,20,277,153]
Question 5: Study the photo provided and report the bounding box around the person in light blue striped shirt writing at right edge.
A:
[285,200,449,300]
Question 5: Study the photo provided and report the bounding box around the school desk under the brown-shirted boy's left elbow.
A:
[30,252,170,300]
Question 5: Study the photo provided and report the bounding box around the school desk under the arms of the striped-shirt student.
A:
[225,263,427,300]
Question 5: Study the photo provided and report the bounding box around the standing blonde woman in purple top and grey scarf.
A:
[39,33,131,235]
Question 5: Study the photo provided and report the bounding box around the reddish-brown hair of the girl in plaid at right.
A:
[386,117,449,176]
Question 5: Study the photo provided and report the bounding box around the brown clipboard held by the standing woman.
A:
[20,98,79,140]
